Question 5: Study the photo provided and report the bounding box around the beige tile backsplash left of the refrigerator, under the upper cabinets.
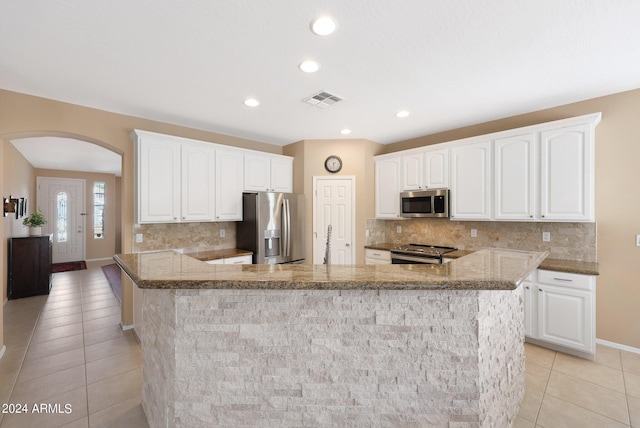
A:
[133,221,236,253]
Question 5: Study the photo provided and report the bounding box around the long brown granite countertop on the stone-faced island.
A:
[114,249,547,290]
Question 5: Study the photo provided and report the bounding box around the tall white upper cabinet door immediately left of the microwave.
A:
[375,156,402,219]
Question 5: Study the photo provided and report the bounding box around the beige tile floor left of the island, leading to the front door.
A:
[0,260,148,428]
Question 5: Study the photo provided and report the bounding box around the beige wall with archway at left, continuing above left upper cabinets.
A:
[0,90,282,348]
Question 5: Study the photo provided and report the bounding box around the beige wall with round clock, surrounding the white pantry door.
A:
[283,139,383,263]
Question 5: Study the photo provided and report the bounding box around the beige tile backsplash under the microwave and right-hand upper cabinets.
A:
[366,218,597,262]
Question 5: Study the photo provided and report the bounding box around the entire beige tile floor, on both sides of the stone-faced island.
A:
[0,261,640,428]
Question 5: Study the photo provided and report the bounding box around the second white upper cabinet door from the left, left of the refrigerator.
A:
[180,143,215,221]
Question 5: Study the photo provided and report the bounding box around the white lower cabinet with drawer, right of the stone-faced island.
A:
[523,270,596,355]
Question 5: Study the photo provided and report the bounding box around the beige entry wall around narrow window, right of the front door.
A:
[35,168,121,260]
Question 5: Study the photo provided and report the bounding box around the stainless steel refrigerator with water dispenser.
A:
[236,192,305,264]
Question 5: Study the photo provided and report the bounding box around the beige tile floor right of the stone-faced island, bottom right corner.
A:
[514,343,640,428]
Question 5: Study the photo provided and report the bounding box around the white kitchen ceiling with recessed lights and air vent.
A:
[0,0,640,152]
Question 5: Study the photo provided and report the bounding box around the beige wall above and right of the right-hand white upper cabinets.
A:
[385,89,640,348]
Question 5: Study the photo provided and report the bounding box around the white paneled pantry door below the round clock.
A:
[313,176,356,265]
